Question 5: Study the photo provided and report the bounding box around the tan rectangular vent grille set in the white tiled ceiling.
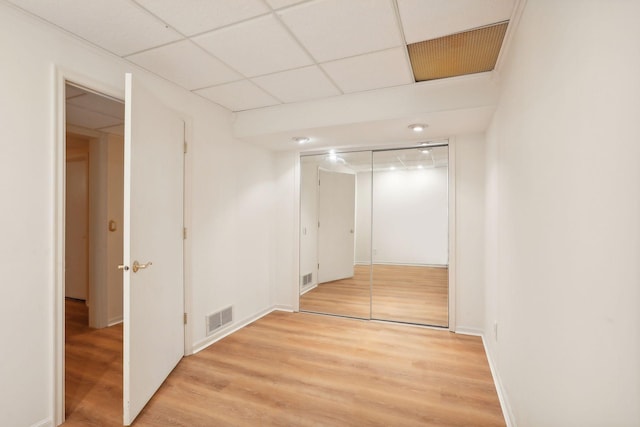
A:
[407,21,509,82]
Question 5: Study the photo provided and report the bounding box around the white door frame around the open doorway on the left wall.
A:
[51,66,193,425]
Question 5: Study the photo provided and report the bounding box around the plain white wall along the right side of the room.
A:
[485,0,640,427]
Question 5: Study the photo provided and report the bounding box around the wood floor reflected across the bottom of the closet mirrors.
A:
[300,264,449,327]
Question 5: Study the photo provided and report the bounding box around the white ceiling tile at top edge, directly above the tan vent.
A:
[398,0,515,43]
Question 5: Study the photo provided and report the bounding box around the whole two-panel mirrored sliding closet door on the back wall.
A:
[300,144,449,327]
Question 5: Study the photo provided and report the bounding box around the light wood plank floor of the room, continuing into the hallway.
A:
[67,300,505,427]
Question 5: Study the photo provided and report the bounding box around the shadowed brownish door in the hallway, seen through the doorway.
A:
[64,153,89,300]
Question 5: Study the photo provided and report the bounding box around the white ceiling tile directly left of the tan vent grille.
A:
[322,47,414,93]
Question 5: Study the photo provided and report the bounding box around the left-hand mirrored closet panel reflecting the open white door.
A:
[300,152,371,319]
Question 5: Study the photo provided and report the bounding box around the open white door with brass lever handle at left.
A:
[123,74,184,425]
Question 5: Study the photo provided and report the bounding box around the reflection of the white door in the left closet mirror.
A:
[318,169,356,283]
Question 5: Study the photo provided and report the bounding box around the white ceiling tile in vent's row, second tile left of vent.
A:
[252,66,341,102]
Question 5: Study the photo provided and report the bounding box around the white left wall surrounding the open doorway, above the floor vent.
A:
[0,3,275,426]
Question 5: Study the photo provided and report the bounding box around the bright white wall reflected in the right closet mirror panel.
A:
[371,166,449,265]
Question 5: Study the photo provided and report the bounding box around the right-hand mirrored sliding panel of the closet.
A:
[371,146,449,327]
